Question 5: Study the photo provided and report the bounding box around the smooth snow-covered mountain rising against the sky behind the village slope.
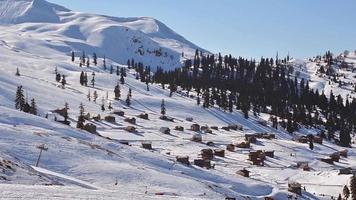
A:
[0,0,200,69]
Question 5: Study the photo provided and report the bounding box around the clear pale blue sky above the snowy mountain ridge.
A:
[49,0,356,58]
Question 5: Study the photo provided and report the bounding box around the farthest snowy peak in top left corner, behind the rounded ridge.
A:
[0,0,69,24]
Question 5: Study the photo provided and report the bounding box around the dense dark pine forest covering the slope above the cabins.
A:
[152,50,356,146]
